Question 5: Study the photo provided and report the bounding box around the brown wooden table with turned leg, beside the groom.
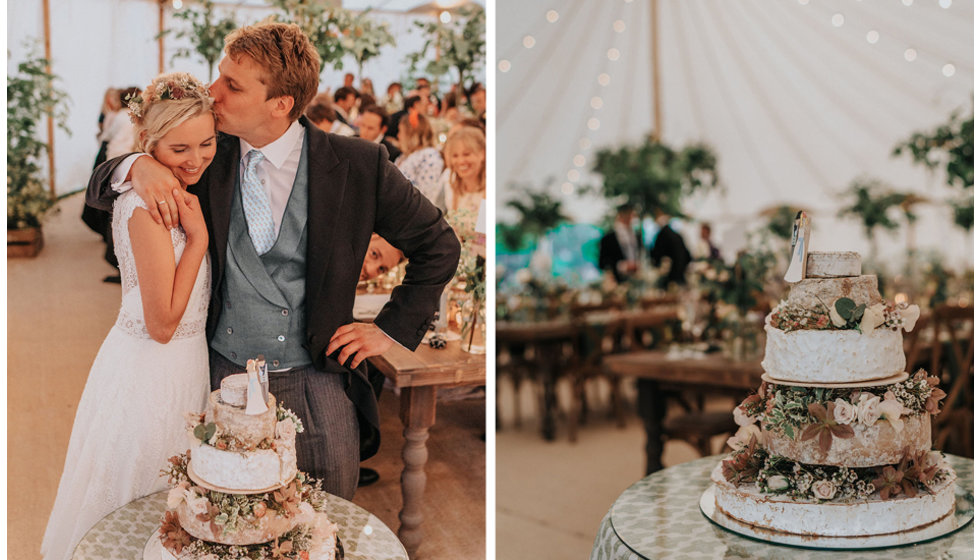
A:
[368,334,487,558]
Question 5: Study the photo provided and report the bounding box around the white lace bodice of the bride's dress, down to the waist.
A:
[112,190,211,339]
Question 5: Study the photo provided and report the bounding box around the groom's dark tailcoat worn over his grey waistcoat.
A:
[85,117,460,458]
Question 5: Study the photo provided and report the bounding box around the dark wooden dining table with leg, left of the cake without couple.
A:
[603,350,763,474]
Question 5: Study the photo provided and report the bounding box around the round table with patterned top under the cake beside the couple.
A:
[72,492,408,560]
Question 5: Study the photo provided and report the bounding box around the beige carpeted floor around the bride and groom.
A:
[7,194,486,560]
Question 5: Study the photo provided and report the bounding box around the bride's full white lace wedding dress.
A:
[41,191,211,560]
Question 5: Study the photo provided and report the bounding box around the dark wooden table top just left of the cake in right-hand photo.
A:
[602,350,763,390]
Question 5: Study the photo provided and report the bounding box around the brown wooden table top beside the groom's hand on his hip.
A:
[368,340,487,387]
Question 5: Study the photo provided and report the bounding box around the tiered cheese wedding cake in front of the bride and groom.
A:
[151,366,343,560]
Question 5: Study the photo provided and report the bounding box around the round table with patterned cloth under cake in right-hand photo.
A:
[591,455,973,560]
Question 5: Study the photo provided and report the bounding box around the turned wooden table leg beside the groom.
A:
[398,386,436,558]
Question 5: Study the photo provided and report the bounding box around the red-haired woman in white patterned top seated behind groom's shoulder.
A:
[395,111,444,203]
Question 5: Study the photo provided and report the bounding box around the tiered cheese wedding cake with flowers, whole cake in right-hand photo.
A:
[711,252,955,537]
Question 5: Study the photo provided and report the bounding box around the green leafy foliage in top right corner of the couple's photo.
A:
[406,5,487,91]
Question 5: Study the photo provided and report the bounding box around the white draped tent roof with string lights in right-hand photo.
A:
[496,0,973,263]
